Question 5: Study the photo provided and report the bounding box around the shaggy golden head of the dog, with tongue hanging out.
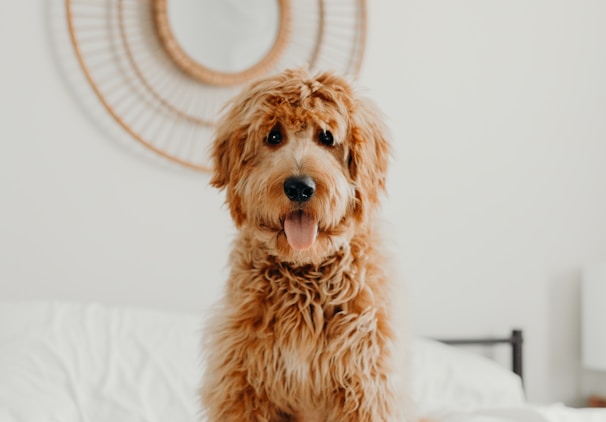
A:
[211,69,389,262]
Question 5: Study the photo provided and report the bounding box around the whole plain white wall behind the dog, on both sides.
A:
[0,0,606,403]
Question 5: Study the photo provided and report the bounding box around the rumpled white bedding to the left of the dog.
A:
[0,303,201,422]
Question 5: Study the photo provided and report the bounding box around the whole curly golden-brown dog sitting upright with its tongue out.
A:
[201,69,402,422]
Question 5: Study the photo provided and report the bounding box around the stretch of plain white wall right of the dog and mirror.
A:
[363,0,606,402]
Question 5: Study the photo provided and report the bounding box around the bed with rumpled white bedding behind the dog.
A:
[0,302,606,422]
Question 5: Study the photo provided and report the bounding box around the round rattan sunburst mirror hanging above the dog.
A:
[65,0,366,171]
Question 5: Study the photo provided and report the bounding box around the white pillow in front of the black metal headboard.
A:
[412,339,525,416]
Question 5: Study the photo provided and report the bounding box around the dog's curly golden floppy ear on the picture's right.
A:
[349,98,391,217]
